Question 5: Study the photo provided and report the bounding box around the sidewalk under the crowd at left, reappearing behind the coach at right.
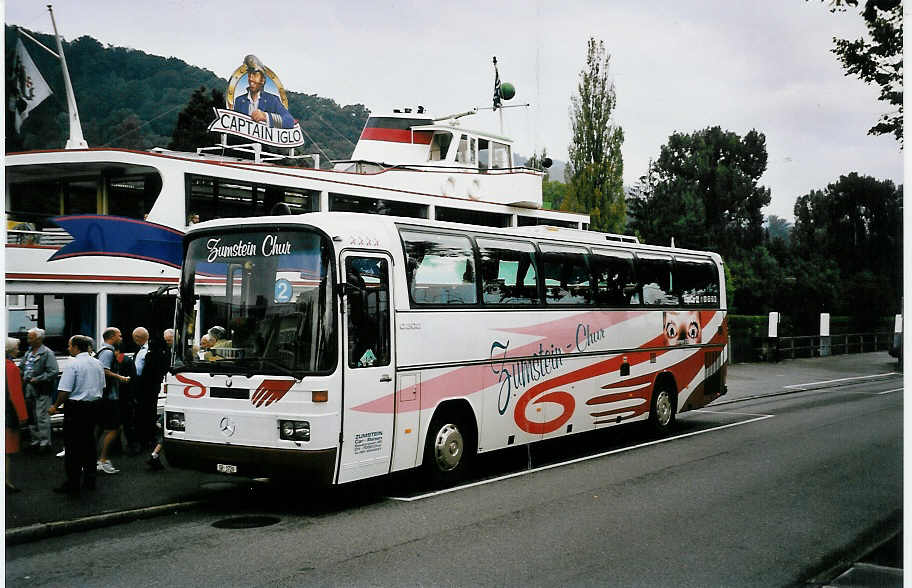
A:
[6,351,902,545]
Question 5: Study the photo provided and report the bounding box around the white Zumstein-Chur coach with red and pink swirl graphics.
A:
[164,212,727,484]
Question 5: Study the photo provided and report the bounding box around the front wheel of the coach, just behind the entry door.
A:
[424,414,475,484]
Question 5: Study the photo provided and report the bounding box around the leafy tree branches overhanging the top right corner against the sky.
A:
[816,0,903,149]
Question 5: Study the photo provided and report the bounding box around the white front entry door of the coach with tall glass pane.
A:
[339,253,396,483]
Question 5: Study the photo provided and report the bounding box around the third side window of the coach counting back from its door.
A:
[539,245,593,305]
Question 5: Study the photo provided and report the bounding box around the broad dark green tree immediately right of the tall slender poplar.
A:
[629,126,770,258]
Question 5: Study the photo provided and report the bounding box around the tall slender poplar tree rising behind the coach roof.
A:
[561,38,626,233]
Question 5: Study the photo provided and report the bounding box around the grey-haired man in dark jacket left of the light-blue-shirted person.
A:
[21,328,57,452]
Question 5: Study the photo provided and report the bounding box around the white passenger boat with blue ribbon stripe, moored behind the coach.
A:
[5,109,589,352]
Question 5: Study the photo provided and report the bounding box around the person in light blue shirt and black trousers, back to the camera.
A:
[48,335,105,496]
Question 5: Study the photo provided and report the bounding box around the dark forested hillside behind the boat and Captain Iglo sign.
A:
[5,26,368,159]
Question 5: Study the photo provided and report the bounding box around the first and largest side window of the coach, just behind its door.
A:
[400,230,478,305]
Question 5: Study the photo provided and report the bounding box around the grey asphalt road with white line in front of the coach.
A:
[6,354,902,586]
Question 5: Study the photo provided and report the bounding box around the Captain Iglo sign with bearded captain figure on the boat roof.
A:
[209,55,304,148]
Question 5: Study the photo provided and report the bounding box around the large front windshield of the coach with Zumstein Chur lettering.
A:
[175,226,337,377]
